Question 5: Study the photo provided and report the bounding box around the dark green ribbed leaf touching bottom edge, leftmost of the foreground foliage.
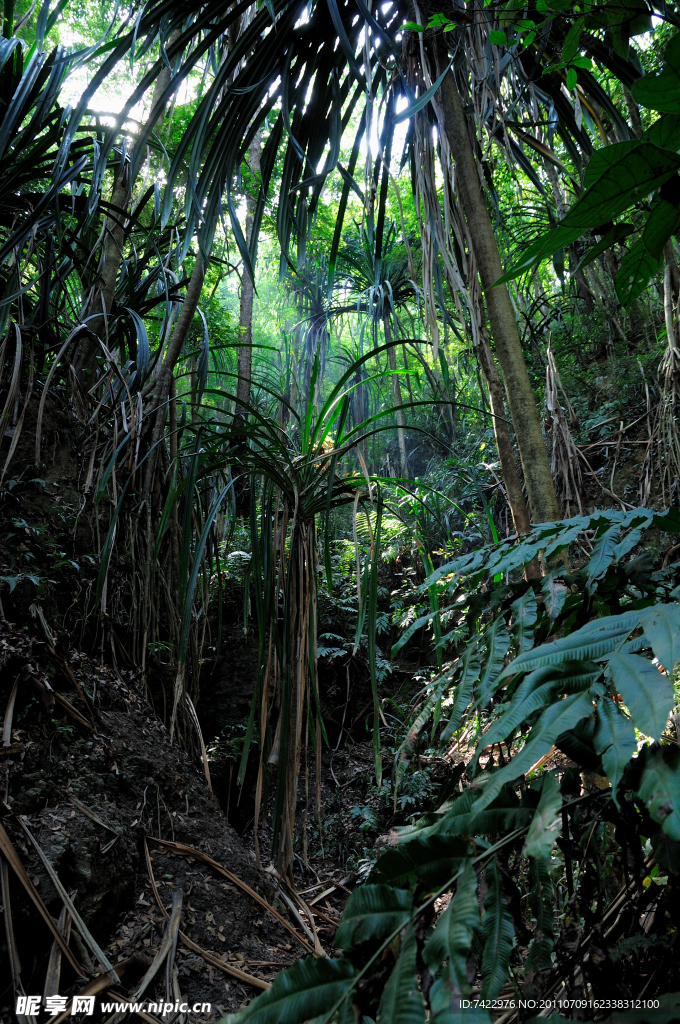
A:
[224,957,355,1024]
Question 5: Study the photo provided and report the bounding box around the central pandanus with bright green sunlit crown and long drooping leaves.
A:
[232,346,409,872]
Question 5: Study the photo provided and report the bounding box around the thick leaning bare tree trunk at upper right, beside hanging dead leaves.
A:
[432,33,559,522]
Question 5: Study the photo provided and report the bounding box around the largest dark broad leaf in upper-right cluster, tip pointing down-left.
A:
[562,142,680,230]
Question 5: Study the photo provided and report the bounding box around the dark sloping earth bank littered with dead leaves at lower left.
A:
[0,623,360,1022]
